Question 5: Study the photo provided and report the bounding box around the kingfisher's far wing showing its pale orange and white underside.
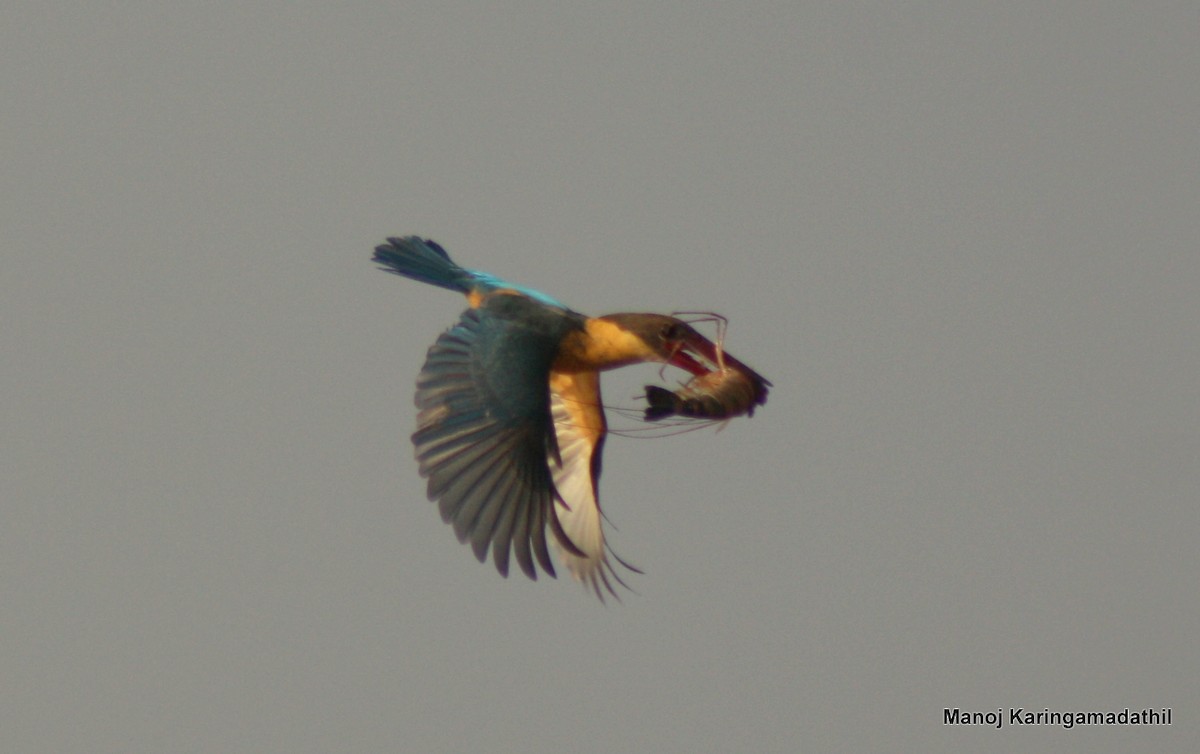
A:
[550,372,637,600]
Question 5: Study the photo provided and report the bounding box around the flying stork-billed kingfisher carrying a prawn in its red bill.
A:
[374,237,770,599]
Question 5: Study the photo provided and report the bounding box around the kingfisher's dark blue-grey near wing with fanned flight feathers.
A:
[413,294,582,579]
